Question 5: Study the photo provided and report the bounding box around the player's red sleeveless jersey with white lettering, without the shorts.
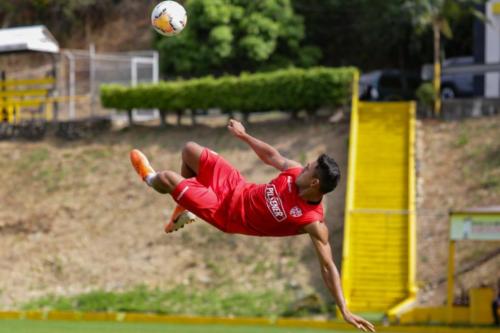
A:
[226,167,323,236]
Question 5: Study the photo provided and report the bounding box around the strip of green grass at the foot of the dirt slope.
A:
[22,286,310,317]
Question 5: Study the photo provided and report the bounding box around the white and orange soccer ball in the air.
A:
[151,1,187,36]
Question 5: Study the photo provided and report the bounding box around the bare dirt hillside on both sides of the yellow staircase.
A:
[0,112,500,309]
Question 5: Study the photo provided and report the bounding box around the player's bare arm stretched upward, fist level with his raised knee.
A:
[227,119,301,171]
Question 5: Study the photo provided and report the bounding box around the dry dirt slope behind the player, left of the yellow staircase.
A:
[0,120,348,308]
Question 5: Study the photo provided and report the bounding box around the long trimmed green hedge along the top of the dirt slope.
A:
[101,67,355,112]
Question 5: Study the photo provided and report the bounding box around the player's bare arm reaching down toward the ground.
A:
[304,222,375,332]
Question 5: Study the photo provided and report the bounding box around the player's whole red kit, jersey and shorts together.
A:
[172,149,323,236]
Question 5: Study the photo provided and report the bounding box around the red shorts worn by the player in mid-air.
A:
[172,148,245,231]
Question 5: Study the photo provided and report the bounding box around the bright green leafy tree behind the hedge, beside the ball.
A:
[155,0,320,76]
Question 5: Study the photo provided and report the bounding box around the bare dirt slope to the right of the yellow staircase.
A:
[417,115,500,305]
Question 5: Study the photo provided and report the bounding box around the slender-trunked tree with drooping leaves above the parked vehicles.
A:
[406,0,485,115]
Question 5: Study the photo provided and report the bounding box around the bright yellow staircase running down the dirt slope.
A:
[342,100,416,314]
